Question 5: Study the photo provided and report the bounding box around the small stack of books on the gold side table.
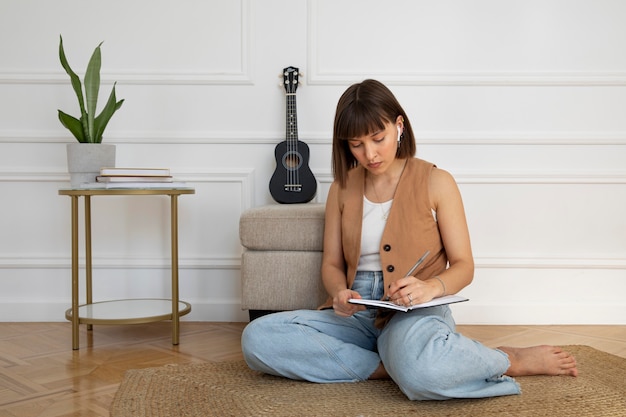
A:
[85,168,186,188]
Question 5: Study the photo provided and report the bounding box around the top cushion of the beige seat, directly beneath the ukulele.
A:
[239,203,324,252]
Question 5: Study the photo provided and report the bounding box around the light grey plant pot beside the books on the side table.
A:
[67,142,115,188]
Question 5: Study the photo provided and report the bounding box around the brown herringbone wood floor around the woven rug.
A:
[0,322,626,417]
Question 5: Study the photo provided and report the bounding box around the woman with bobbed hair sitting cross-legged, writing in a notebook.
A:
[242,80,578,400]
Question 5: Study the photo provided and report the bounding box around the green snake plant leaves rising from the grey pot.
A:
[59,36,124,143]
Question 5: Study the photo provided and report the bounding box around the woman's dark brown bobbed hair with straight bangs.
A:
[332,80,416,187]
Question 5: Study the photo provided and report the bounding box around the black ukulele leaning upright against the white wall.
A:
[270,67,317,204]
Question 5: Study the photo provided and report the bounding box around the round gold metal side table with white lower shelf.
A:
[59,188,195,350]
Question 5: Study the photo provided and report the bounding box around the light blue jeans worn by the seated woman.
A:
[241,272,520,400]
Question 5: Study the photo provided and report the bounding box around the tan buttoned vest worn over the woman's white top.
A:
[324,158,448,327]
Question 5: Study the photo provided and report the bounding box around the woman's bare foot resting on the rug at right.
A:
[498,345,578,376]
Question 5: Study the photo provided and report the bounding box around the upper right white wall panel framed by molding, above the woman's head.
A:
[307,0,626,87]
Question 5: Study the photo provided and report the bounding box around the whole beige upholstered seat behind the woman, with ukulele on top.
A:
[239,203,327,320]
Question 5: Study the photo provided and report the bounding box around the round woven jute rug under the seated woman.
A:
[110,346,626,417]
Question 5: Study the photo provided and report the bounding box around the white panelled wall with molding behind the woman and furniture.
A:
[0,0,626,324]
